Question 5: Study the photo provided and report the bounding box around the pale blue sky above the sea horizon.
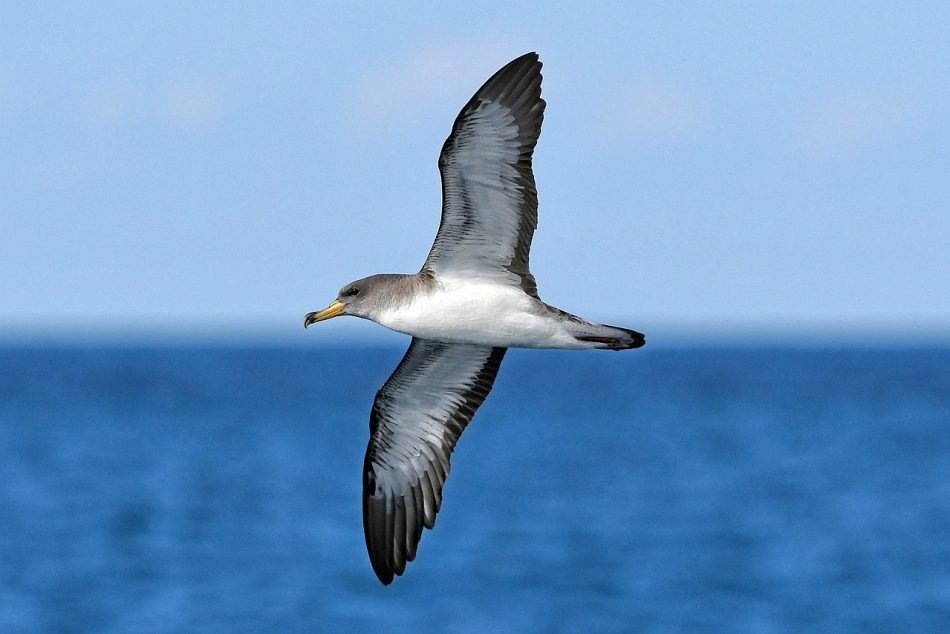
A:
[0,1,950,342]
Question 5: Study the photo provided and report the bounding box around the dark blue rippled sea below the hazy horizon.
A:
[0,346,950,634]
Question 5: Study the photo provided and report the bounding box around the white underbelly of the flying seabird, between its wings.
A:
[377,281,585,348]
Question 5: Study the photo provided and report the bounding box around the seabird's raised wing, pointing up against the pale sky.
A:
[422,53,544,296]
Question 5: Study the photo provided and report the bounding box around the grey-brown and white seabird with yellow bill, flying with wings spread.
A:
[304,53,645,585]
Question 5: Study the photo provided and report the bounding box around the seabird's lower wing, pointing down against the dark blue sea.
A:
[363,338,505,585]
